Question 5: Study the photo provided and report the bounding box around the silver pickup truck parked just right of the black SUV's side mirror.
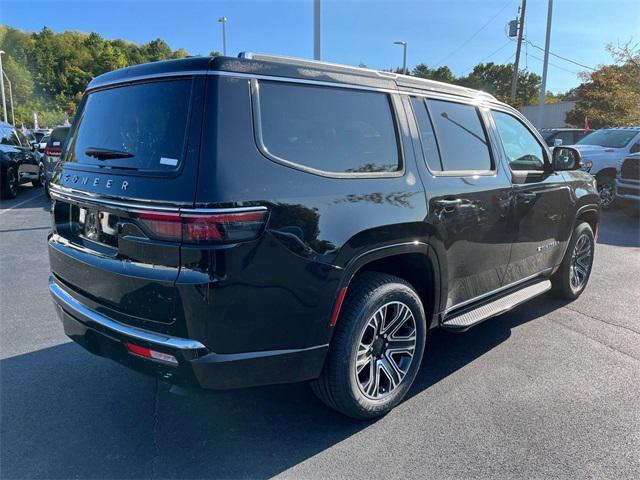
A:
[576,127,640,208]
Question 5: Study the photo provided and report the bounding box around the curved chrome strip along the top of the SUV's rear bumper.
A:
[49,277,206,350]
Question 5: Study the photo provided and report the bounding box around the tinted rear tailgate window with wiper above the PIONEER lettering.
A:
[65,79,193,173]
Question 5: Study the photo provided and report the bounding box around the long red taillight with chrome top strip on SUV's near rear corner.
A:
[136,211,267,244]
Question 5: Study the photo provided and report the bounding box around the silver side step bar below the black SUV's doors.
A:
[441,280,551,332]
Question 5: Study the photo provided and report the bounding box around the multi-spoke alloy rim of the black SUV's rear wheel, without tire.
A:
[355,302,417,400]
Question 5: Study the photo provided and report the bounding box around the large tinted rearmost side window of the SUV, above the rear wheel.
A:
[258,81,399,173]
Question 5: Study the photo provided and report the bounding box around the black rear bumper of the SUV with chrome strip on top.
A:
[49,277,328,390]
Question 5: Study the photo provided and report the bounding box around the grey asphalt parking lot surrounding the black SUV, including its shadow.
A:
[0,183,640,479]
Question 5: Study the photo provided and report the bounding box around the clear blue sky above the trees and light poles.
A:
[0,0,640,92]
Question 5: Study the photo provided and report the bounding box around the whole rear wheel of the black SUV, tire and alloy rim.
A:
[312,272,426,419]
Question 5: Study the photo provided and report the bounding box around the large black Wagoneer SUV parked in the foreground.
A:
[49,54,599,418]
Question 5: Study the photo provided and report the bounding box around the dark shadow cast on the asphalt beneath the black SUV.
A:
[0,296,563,478]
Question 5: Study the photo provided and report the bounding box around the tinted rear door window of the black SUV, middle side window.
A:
[427,100,492,171]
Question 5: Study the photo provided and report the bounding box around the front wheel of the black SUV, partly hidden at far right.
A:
[552,222,595,300]
